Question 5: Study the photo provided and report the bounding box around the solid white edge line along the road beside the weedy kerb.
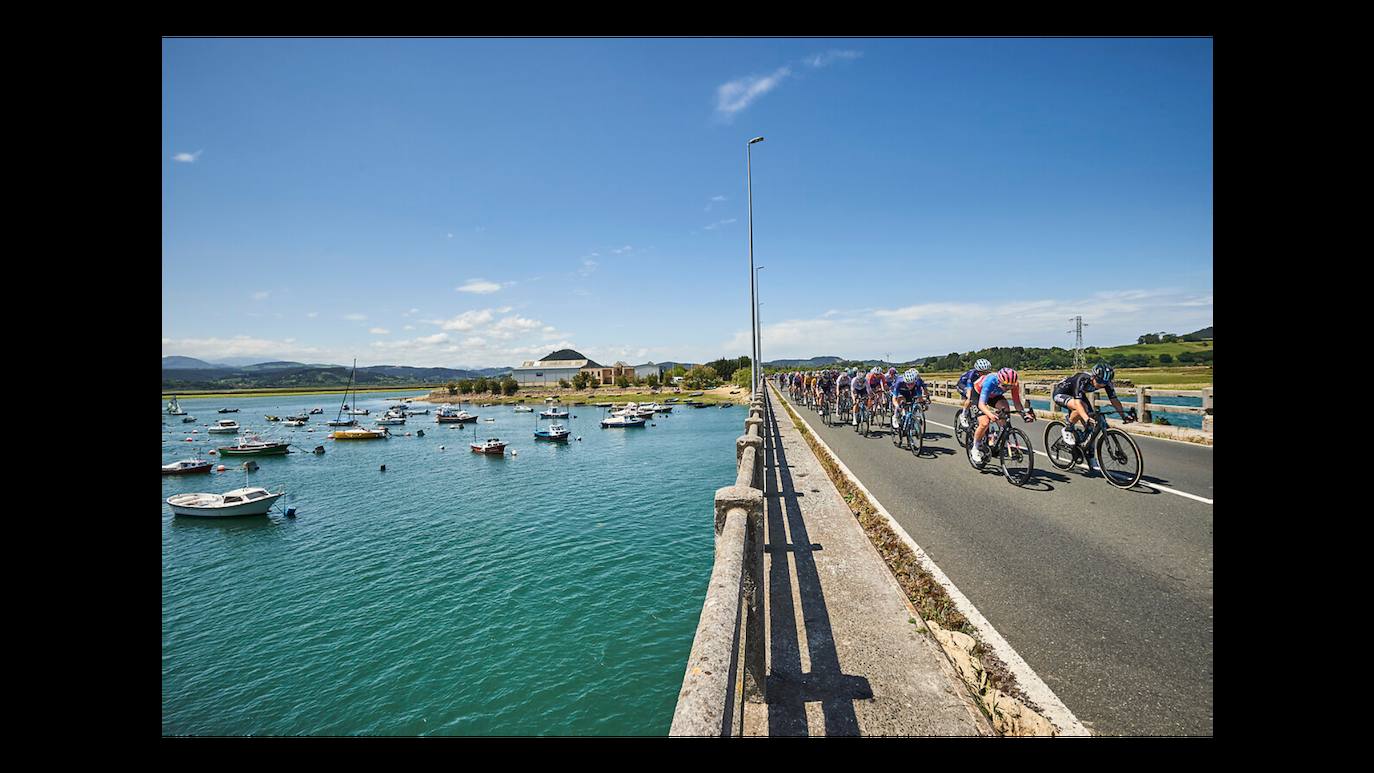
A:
[775,387,1092,736]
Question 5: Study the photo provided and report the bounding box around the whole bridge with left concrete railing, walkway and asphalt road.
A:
[672,389,1213,736]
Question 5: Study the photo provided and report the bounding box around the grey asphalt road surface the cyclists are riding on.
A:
[775,391,1213,735]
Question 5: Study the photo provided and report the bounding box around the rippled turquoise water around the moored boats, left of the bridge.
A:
[162,393,745,736]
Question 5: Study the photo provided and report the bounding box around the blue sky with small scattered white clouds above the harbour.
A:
[162,38,1213,367]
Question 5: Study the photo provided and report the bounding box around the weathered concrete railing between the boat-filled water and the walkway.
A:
[668,390,767,737]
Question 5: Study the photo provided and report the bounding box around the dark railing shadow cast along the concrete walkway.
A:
[764,404,872,736]
